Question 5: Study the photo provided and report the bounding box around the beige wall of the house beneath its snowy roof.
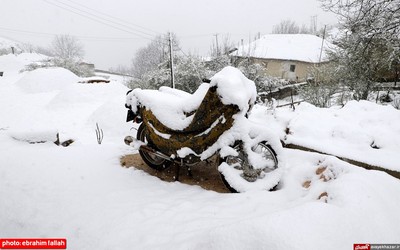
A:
[235,57,315,82]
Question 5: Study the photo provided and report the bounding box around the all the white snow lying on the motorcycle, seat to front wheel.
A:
[127,67,282,192]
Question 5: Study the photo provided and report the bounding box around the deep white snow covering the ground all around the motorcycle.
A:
[0,54,400,249]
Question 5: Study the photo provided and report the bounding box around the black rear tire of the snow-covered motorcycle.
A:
[136,123,172,171]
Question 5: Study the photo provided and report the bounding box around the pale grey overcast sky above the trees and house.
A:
[0,0,336,69]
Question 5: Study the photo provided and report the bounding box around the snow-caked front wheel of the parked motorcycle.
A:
[218,141,279,193]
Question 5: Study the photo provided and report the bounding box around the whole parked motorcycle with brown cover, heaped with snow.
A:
[125,67,282,192]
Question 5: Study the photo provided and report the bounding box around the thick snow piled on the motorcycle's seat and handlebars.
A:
[126,67,257,130]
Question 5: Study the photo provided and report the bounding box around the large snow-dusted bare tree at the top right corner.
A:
[321,0,400,99]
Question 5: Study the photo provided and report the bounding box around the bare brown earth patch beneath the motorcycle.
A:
[121,154,230,193]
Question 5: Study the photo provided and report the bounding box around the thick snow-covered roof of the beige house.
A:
[231,34,334,63]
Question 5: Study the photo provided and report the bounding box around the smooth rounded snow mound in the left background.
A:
[15,68,79,93]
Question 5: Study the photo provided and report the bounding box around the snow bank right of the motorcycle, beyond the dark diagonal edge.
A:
[253,101,400,172]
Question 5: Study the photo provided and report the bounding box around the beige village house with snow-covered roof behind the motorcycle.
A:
[230,34,334,82]
